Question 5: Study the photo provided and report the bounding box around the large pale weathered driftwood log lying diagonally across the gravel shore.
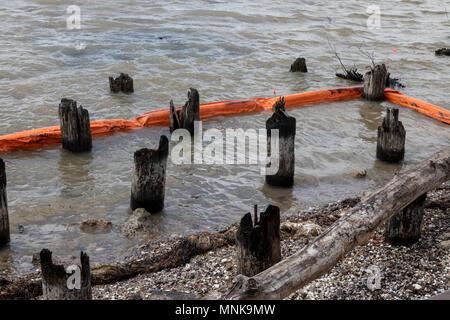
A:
[222,148,450,299]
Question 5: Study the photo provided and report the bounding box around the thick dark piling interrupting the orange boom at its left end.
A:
[58,98,92,152]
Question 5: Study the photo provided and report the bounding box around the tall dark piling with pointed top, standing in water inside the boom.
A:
[266,97,296,187]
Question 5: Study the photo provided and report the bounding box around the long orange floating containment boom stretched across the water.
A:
[0,86,450,152]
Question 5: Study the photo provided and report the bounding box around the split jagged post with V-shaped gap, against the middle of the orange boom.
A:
[170,88,200,136]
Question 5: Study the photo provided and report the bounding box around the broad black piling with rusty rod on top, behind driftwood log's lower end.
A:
[236,205,281,277]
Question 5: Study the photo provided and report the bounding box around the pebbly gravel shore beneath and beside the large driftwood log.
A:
[93,183,450,300]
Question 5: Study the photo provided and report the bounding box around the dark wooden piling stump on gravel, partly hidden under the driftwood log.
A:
[384,193,427,246]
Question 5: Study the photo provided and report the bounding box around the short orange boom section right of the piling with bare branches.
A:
[384,89,450,124]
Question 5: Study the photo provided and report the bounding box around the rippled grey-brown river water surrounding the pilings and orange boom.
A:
[0,0,450,272]
